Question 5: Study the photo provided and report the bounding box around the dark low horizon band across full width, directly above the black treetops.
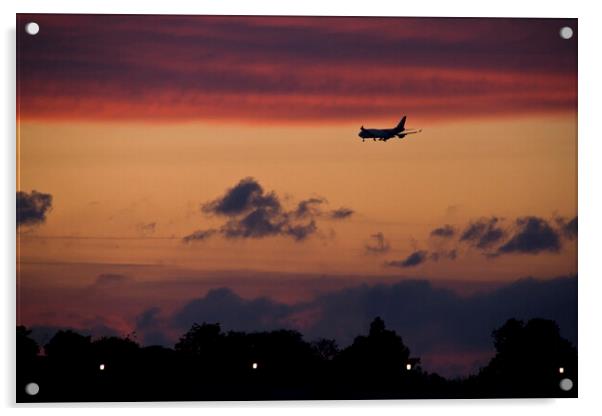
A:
[22,276,578,377]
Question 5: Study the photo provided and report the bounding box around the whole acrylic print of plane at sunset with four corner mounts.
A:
[16,14,578,402]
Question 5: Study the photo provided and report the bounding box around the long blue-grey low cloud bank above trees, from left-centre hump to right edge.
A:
[163,277,577,375]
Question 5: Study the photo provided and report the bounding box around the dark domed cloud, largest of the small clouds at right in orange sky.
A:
[498,217,561,254]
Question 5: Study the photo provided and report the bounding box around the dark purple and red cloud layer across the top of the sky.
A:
[17,15,577,122]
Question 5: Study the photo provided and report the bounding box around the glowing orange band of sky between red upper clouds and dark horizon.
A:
[19,116,577,280]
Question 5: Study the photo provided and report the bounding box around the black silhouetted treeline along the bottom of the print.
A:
[17,318,577,402]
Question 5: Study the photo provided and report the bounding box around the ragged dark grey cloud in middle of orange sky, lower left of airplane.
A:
[183,177,353,243]
